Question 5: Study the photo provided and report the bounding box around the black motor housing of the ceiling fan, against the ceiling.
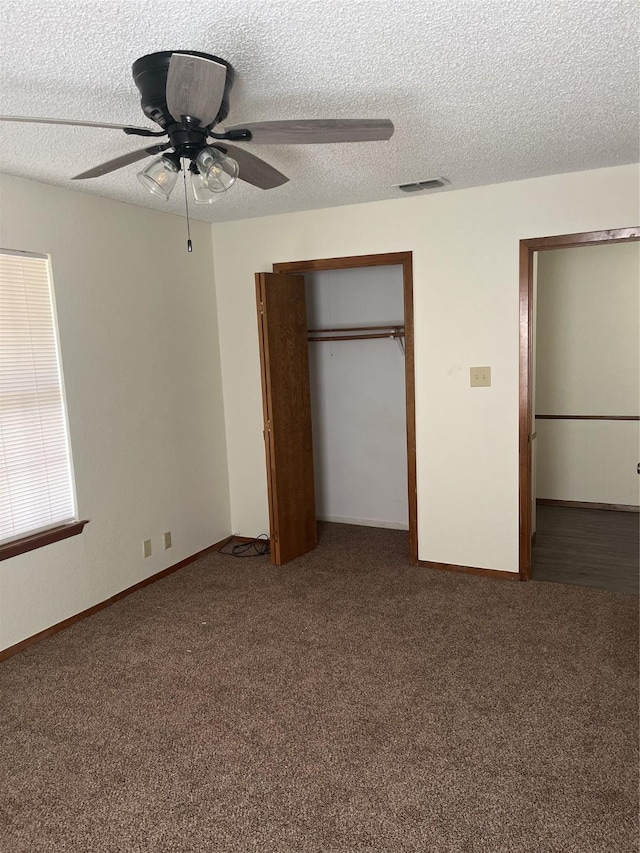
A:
[132,50,234,129]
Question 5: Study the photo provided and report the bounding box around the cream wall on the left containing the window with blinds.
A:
[0,176,230,648]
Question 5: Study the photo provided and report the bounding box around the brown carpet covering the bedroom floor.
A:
[0,525,638,853]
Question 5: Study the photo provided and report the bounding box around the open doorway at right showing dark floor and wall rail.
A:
[520,227,640,592]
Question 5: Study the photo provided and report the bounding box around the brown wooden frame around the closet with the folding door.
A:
[273,252,418,565]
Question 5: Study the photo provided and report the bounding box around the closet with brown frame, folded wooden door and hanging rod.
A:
[256,252,418,565]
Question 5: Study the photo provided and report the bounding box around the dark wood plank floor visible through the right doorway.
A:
[532,506,640,595]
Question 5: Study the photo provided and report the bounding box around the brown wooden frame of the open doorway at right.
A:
[519,227,640,581]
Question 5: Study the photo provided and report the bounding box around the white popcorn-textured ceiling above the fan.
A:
[0,0,639,221]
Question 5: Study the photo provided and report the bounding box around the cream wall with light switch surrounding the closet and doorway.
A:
[213,166,640,572]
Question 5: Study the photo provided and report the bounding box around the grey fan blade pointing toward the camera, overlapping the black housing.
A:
[166,53,227,127]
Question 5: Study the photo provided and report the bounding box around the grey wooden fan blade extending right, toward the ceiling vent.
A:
[225,118,393,145]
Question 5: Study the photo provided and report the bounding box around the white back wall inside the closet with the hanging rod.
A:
[305,266,408,529]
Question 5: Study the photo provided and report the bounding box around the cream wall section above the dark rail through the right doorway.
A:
[536,242,640,415]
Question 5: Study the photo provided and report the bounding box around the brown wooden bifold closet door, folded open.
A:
[256,273,318,566]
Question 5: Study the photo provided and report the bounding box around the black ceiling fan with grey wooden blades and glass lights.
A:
[0,50,394,204]
